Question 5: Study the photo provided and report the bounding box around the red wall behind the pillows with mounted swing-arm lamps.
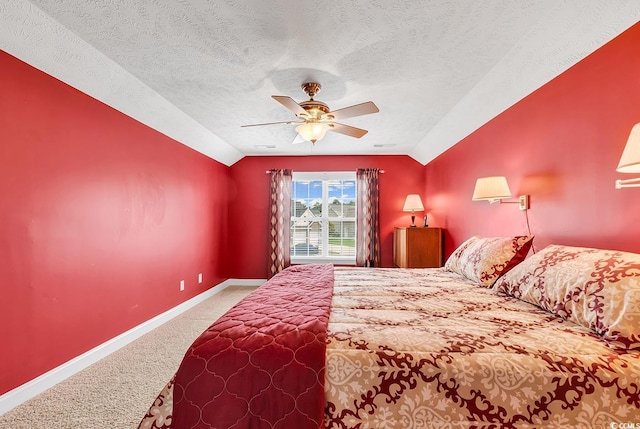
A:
[425,24,640,253]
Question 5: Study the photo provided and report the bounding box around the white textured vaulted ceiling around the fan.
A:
[0,0,640,165]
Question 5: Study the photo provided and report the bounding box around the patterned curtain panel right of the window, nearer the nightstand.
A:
[356,168,380,267]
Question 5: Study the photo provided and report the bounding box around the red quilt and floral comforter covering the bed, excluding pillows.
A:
[140,246,640,429]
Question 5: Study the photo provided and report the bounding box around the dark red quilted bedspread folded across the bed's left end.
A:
[172,265,333,429]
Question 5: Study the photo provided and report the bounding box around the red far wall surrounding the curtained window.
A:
[229,156,424,279]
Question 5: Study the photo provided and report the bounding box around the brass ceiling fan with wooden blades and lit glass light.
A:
[242,82,379,144]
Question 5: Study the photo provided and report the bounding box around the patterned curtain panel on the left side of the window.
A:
[269,170,291,278]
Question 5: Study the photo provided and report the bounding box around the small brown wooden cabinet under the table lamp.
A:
[393,227,442,268]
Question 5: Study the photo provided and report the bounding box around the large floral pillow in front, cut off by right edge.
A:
[494,245,640,350]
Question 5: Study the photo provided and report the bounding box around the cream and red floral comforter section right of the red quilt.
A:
[325,268,640,428]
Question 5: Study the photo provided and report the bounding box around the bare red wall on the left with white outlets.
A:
[0,51,229,394]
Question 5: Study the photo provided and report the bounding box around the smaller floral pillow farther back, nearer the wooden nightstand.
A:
[444,236,533,287]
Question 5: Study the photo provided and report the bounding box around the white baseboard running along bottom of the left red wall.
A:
[0,279,266,416]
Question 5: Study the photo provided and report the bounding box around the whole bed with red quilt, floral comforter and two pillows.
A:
[139,237,640,429]
